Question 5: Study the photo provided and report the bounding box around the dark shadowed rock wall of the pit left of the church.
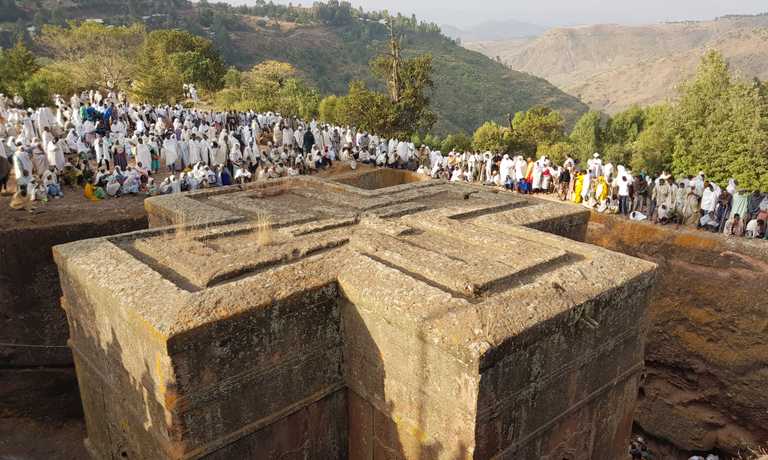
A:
[0,216,147,432]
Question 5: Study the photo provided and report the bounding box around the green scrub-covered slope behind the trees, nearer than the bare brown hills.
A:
[0,0,587,133]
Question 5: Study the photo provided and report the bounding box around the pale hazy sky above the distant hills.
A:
[230,0,768,27]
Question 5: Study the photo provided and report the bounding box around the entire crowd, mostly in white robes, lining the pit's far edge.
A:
[0,91,768,238]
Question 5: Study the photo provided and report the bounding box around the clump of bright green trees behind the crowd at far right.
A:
[569,51,768,190]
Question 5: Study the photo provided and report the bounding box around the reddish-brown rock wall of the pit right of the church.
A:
[587,215,768,455]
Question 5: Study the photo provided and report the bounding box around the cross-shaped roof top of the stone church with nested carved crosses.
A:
[55,170,653,362]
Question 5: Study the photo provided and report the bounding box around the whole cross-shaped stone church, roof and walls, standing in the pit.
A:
[54,171,655,460]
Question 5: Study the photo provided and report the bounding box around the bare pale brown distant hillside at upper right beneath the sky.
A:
[464,15,768,113]
